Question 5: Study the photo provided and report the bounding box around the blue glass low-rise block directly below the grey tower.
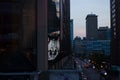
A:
[86,40,110,55]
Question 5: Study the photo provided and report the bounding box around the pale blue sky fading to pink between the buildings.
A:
[70,0,110,38]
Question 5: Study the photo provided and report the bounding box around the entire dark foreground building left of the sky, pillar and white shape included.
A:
[0,0,71,72]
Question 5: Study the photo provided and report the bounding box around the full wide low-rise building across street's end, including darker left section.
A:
[74,37,110,55]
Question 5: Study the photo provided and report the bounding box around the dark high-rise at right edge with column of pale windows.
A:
[110,0,120,66]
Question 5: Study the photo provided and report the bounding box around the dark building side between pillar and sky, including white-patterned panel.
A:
[48,0,71,67]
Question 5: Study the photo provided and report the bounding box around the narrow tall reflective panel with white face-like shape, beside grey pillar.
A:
[48,0,60,61]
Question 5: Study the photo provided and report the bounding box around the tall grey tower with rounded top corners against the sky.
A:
[86,14,98,39]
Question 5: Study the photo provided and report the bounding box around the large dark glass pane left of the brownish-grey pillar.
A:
[0,0,37,72]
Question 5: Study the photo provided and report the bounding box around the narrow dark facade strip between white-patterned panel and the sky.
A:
[61,0,71,59]
